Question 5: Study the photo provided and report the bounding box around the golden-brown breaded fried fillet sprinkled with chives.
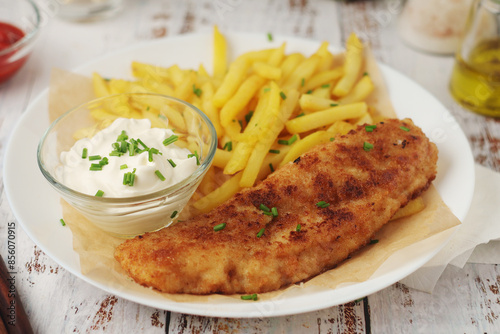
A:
[115,119,437,294]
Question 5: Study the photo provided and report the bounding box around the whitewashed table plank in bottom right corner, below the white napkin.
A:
[369,264,500,333]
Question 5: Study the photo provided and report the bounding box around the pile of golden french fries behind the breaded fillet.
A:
[93,27,423,219]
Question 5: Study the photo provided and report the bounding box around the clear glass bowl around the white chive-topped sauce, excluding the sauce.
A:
[37,93,217,238]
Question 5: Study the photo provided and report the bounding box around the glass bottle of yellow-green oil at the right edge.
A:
[450,0,500,117]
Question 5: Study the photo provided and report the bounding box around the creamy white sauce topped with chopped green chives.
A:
[56,118,198,197]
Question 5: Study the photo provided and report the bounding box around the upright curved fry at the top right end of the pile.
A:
[332,33,363,97]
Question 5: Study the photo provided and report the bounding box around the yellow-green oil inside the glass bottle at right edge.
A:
[450,39,500,117]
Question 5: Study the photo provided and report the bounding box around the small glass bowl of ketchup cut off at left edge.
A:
[0,0,41,84]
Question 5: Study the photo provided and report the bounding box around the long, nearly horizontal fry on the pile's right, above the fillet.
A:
[285,102,367,133]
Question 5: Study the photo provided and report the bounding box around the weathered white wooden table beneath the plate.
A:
[0,0,500,333]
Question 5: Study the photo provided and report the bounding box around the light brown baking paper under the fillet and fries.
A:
[49,44,460,303]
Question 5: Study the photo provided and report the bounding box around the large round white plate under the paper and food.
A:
[4,34,474,317]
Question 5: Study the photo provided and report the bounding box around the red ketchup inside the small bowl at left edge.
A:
[0,22,28,83]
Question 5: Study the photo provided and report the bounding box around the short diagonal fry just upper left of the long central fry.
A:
[220,75,266,127]
